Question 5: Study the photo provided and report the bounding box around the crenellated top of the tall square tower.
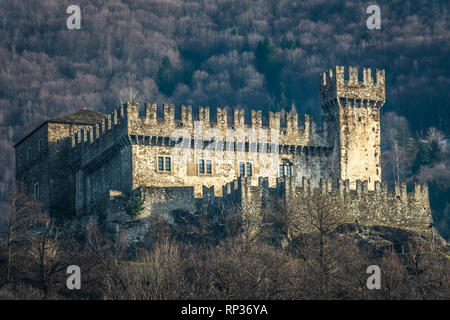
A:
[319,66,386,107]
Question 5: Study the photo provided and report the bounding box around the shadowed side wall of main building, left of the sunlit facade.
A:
[69,108,133,216]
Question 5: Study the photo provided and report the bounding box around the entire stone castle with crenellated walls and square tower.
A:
[15,66,431,239]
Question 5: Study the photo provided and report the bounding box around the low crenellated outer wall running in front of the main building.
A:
[121,177,431,231]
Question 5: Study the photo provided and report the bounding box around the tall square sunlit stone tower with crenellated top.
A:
[320,66,386,190]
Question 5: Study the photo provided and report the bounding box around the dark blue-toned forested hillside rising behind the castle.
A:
[0,0,450,235]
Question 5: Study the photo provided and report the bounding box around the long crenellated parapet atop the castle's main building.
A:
[71,102,326,148]
